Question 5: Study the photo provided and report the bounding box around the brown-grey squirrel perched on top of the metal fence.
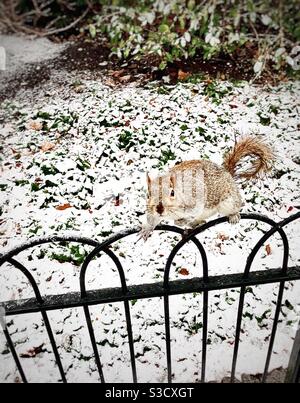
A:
[141,136,275,240]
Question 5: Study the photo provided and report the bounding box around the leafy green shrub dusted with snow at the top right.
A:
[88,0,300,74]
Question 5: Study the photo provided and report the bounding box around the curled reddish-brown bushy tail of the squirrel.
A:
[223,136,275,179]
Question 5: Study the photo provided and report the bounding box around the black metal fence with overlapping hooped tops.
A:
[0,212,300,382]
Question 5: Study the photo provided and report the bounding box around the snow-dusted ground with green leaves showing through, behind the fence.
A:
[0,37,300,382]
